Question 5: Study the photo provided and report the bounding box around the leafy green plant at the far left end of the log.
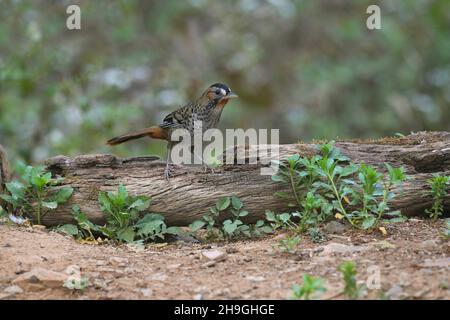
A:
[0,164,73,224]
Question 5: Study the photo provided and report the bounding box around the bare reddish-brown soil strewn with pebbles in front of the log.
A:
[0,219,450,299]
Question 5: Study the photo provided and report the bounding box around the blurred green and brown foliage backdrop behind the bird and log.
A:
[0,0,450,162]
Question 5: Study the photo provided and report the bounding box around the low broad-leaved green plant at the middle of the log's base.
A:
[189,196,273,240]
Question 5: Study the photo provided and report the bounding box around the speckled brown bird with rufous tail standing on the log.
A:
[106,83,238,181]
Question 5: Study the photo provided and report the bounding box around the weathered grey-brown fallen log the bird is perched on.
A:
[44,132,450,225]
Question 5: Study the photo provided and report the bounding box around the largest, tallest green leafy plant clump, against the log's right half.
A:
[270,141,406,232]
